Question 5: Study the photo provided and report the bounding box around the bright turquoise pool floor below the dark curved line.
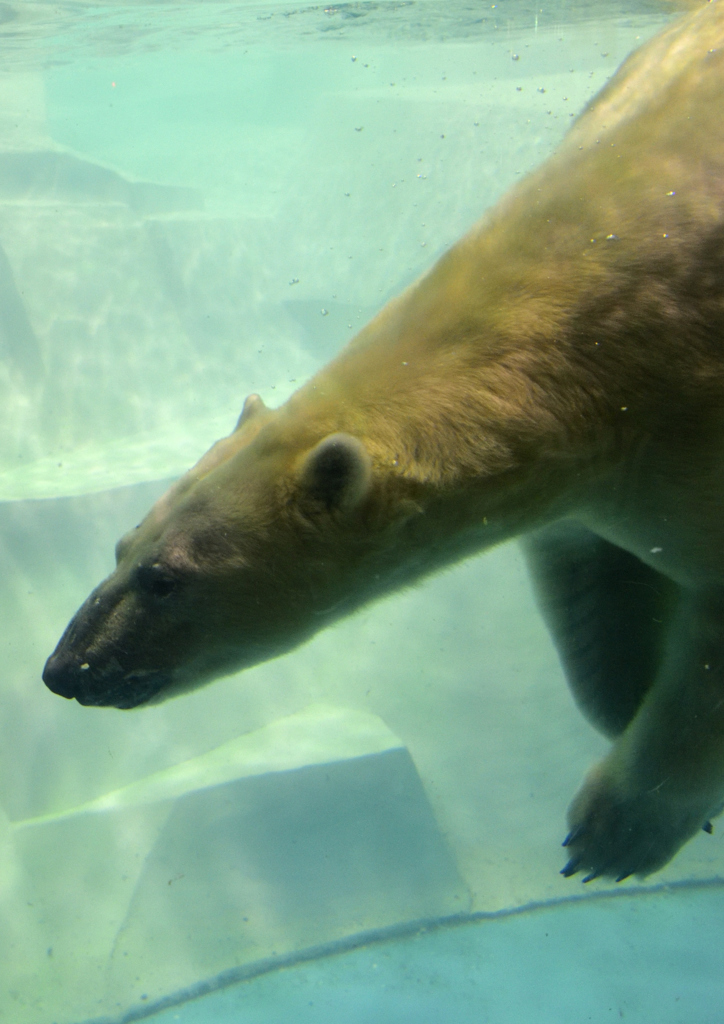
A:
[151,886,724,1024]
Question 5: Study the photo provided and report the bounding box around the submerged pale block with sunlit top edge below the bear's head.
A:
[0,707,470,1024]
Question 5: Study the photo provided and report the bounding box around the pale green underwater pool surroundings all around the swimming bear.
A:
[0,0,724,1024]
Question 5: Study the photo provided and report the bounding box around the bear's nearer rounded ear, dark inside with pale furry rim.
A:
[300,434,372,510]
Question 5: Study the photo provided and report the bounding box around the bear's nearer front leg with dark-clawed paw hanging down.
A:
[562,592,724,882]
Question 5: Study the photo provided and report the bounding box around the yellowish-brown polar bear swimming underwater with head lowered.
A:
[43,2,724,879]
